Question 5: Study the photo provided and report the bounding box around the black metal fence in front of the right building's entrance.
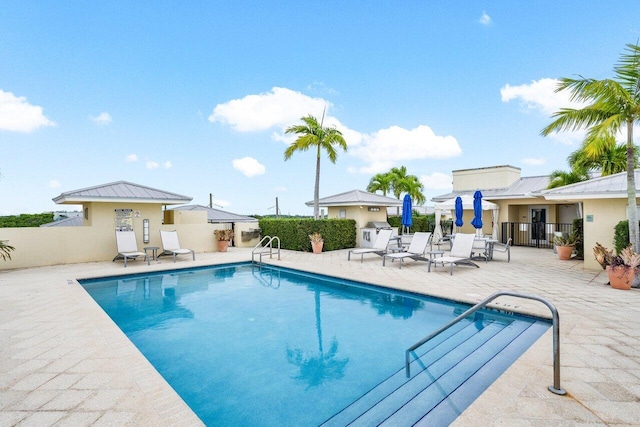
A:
[500,222,573,249]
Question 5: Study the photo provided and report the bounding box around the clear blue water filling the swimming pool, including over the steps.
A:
[80,264,549,426]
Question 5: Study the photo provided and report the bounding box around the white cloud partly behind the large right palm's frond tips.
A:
[500,78,586,145]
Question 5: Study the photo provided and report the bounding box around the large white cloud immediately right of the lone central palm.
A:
[349,125,462,174]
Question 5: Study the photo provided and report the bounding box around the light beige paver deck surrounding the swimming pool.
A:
[0,247,640,426]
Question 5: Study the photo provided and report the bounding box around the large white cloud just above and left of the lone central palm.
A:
[209,87,331,132]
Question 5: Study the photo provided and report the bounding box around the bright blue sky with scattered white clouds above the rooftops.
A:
[0,0,640,215]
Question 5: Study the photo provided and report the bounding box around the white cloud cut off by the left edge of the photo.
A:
[0,90,56,133]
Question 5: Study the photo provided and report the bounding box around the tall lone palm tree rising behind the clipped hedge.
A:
[284,112,347,219]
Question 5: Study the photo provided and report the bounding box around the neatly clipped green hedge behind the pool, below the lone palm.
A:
[258,218,356,252]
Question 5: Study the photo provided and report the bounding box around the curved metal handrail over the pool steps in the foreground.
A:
[405,291,567,396]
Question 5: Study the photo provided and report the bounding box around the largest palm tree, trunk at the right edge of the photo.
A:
[541,44,640,251]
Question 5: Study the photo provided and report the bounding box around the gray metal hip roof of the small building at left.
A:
[53,181,192,205]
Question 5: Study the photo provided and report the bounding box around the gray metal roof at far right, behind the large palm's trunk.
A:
[542,169,640,200]
